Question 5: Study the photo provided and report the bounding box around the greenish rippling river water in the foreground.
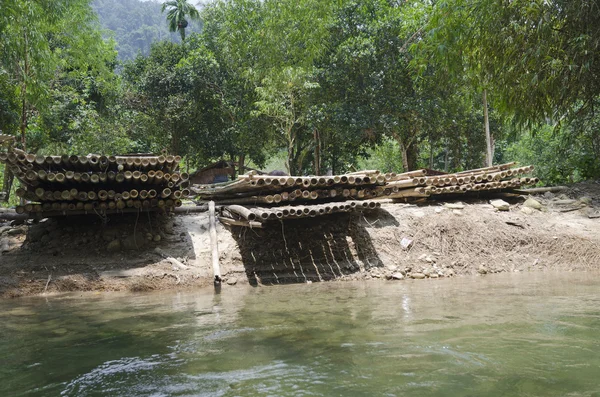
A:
[0,274,600,396]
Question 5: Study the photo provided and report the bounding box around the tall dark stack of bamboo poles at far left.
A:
[0,149,189,217]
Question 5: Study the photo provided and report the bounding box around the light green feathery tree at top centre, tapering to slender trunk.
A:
[204,0,336,173]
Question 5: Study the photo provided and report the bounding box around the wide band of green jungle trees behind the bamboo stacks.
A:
[0,0,600,198]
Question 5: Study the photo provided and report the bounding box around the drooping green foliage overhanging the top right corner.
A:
[430,0,600,124]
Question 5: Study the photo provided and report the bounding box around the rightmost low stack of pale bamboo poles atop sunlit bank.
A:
[383,163,539,201]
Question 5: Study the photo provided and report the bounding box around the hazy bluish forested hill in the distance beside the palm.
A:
[92,0,199,61]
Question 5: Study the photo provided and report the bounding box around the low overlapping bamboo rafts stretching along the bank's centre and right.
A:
[191,163,539,227]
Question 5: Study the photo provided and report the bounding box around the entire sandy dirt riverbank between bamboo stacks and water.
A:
[0,182,600,297]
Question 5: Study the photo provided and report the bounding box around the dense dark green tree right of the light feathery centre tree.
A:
[319,1,431,170]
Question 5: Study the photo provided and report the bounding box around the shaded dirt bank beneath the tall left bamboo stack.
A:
[0,212,195,296]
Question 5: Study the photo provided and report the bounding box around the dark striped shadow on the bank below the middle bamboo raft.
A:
[232,210,393,285]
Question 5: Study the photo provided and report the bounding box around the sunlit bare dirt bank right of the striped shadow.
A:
[373,204,600,274]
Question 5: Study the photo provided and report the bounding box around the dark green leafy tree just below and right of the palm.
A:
[178,36,272,173]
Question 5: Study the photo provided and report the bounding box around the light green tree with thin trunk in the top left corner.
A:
[0,0,109,148]
